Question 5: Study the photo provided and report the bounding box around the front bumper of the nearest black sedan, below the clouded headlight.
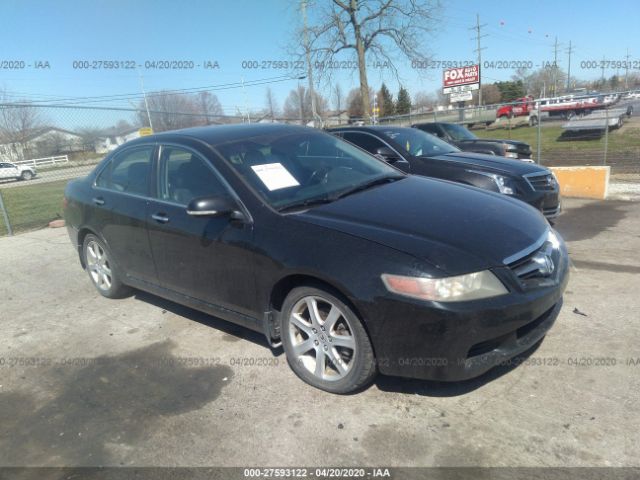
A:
[368,256,568,381]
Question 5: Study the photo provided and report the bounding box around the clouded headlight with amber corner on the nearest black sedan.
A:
[382,270,508,302]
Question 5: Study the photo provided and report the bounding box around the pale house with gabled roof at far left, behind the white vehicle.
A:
[0,127,84,162]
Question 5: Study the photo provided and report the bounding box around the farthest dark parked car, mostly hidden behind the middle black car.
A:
[412,122,531,161]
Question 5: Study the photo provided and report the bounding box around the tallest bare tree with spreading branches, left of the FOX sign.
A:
[311,0,437,122]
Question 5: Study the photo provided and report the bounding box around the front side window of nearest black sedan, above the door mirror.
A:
[158,146,229,205]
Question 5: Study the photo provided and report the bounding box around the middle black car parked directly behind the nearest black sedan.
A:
[328,126,560,221]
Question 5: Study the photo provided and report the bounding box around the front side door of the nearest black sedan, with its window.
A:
[148,144,255,315]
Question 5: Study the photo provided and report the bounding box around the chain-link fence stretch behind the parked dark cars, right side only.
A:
[378,100,640,174]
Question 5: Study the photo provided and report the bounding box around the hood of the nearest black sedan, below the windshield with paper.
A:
[294,176,548,275]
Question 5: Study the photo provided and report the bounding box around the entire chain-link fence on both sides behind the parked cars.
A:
[0,99,640,236]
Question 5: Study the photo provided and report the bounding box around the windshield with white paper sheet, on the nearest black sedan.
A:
[216,131,404,210]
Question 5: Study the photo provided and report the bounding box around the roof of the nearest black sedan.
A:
[128,123,319,146]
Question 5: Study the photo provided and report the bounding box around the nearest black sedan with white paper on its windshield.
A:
[65,125,568,393]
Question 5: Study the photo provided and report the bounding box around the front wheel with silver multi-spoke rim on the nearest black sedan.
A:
[280,287,376,394]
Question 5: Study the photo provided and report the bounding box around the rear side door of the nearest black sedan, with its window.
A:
[90,144,157,283]
